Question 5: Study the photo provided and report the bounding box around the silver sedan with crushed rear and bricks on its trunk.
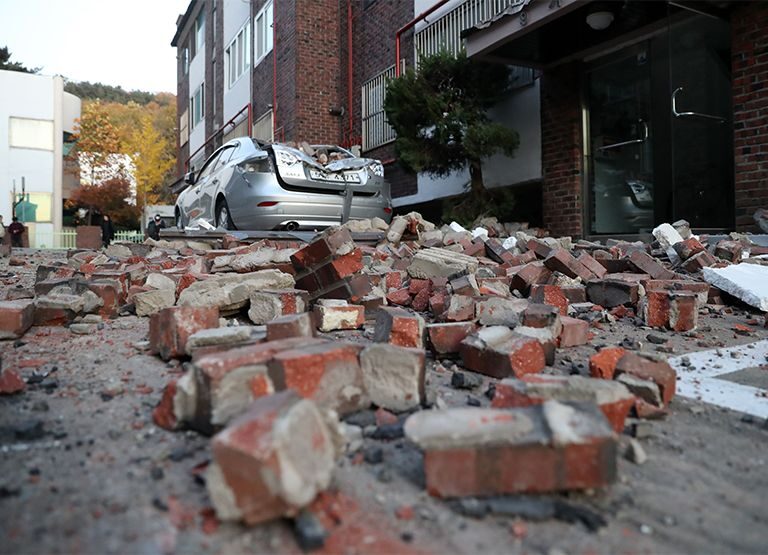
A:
[175,137,392,230]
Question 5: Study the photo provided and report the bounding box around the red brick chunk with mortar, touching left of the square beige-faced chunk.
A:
[268,342,370,415]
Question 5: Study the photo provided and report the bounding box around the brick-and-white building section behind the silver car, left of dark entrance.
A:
[171,0,541,216]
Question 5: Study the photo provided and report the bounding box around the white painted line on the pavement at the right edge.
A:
[669,341,768,418]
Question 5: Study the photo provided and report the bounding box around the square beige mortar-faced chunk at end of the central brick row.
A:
[360,343,425,412]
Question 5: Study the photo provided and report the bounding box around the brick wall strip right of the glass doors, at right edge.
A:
[731,2,768,231]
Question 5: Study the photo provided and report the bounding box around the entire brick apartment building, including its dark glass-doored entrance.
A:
[173,0,768,238]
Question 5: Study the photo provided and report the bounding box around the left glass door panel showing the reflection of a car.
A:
[587,43,654,234]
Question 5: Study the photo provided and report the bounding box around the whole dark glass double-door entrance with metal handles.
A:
[585,11,734,235]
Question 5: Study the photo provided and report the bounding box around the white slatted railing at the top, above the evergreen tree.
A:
[414,0,525,67]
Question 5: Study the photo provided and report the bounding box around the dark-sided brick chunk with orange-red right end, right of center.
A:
[459,326,546,378]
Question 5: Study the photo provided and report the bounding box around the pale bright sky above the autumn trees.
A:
[0,0,189,94]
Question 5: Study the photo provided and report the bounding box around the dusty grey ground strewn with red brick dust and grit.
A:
[0,251,768,554]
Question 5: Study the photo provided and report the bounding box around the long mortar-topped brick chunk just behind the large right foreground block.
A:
[491,374,635,433]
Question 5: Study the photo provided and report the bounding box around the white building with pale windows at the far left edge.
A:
[0,70,81,246]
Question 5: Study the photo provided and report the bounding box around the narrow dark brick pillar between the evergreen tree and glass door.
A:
[541,63,583,237]
